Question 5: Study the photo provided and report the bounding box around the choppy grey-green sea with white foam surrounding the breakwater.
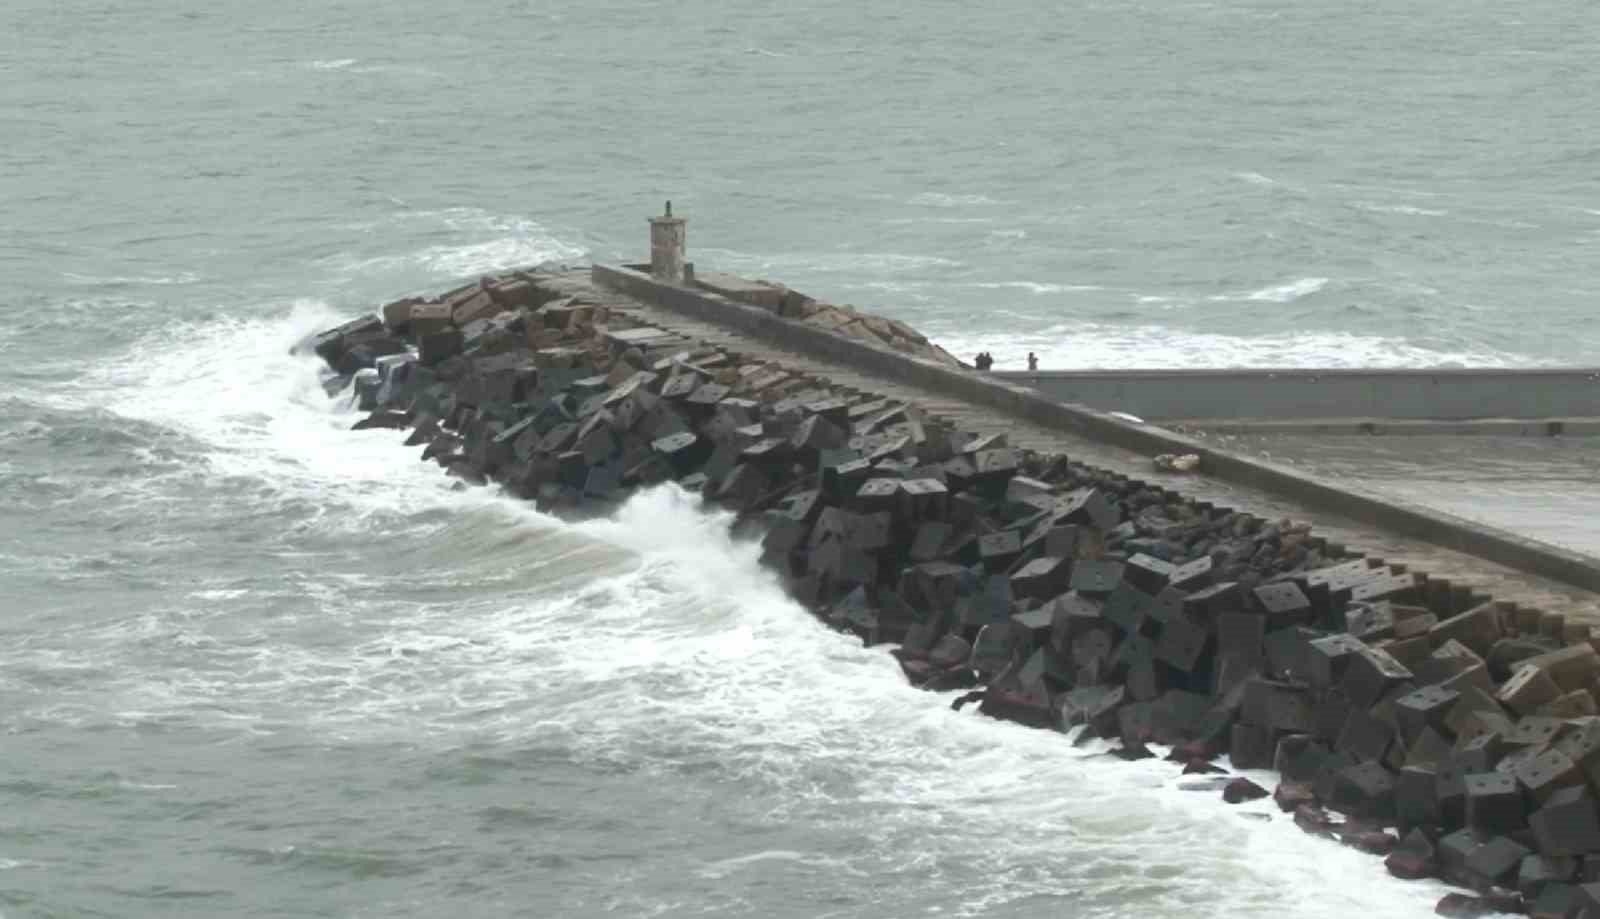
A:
[0,0,1600,917]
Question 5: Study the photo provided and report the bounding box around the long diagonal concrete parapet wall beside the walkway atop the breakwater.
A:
[590,264,1600,591]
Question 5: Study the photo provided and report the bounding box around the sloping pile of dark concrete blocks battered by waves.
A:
[306,272,1600,916]
